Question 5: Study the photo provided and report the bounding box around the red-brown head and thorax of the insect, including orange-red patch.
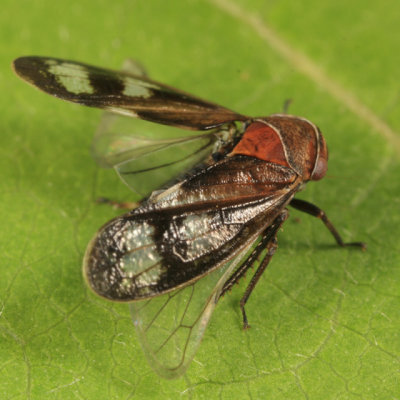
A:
[231,114,328,181]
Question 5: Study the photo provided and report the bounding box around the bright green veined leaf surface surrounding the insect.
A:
[0,0,400,400]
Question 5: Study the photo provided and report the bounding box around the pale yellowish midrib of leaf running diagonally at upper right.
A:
[209,0,400,155]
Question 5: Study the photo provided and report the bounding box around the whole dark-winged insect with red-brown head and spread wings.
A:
[14,56,365,378]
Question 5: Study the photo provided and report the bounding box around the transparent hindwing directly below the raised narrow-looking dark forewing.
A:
[92,112,225,197]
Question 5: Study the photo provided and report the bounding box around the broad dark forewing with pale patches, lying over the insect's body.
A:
[84,156,299,301]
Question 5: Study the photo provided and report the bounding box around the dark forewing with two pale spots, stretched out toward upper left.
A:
[14,56,248,130]
